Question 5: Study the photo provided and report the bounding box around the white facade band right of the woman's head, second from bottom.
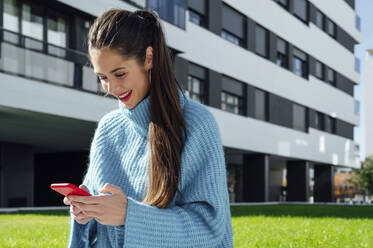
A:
[180,23,359,125]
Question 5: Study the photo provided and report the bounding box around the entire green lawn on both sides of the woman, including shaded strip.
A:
[0,205,373,248]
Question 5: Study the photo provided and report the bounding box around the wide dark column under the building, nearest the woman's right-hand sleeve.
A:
[242,154,269,202]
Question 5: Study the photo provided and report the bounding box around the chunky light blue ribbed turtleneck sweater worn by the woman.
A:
[69,91,233,248]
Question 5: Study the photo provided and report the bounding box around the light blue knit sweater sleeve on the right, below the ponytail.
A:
[118,110,230,247]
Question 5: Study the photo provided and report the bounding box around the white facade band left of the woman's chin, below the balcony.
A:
[0,73,118,122]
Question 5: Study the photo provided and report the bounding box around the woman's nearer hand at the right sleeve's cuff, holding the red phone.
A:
[68,183,128,226]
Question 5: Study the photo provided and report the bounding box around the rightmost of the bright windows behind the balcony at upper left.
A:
[47,14,67,57]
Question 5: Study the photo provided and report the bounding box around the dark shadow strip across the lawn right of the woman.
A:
[231,205,373,219]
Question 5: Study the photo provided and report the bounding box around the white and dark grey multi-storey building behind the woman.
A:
[0,0,361,207]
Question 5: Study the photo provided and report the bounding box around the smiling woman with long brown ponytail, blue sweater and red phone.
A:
[64,10,233,247]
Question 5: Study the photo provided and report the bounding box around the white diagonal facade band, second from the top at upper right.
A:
[224,0,360,83]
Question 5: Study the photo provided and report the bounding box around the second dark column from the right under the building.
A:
[286,160,309,202]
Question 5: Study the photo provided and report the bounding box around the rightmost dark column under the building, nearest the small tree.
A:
[313,164,334,202]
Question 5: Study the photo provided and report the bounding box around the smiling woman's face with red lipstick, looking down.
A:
[90,48,151,109]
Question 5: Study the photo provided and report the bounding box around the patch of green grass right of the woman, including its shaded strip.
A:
[231,205,373,248]
